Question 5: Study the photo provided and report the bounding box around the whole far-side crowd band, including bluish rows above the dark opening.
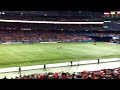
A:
[0,30,120,43]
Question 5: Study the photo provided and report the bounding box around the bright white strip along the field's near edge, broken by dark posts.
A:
[0,58,119,73]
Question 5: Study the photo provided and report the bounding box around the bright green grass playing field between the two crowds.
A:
[0,43,120,68]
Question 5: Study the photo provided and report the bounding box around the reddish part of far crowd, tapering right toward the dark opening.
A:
[0,30,91,42]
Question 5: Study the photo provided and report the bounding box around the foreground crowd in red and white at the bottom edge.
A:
[4,68,120,79]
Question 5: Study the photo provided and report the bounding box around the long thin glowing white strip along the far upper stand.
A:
[0,19,104,24]
